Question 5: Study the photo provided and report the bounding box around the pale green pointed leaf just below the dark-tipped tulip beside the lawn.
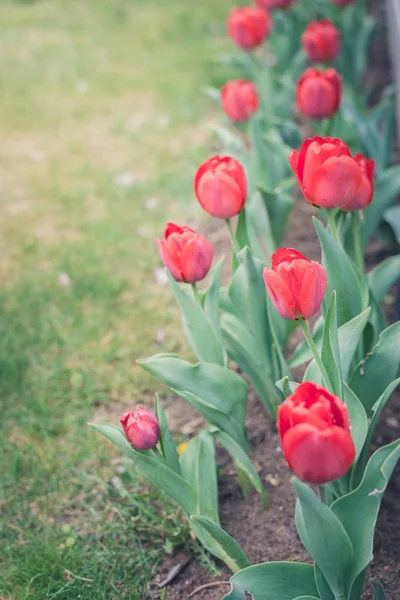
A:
[167,271,225,365]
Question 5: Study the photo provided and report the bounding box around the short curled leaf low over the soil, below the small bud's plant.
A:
[190,515,250,573]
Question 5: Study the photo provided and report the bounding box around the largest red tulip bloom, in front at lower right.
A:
[278,381,355,484]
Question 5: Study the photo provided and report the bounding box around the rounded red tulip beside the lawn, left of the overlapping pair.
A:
[194,156,247,219]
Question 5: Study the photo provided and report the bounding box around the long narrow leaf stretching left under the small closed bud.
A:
[91,423,197,514]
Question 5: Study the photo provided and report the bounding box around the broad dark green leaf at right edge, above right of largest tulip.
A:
[350,321,400,415]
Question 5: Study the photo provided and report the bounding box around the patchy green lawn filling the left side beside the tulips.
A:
[0,0,238,600]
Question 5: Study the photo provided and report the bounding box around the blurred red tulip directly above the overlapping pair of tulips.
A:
[296,68,342,119]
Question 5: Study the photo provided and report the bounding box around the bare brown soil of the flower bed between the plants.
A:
[150,0,400,600]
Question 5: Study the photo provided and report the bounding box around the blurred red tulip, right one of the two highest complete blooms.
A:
[301,19,340,62]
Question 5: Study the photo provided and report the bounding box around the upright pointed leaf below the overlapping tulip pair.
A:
[314,218,368,326]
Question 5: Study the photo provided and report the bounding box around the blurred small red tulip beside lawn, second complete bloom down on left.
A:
[221,79,258,123]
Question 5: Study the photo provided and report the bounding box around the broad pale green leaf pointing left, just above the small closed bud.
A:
[138,354,248,436]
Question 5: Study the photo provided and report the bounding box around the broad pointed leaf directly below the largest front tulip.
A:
[292,478,353,598]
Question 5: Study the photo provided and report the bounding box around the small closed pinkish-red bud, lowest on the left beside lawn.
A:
[120,406,160,450]
